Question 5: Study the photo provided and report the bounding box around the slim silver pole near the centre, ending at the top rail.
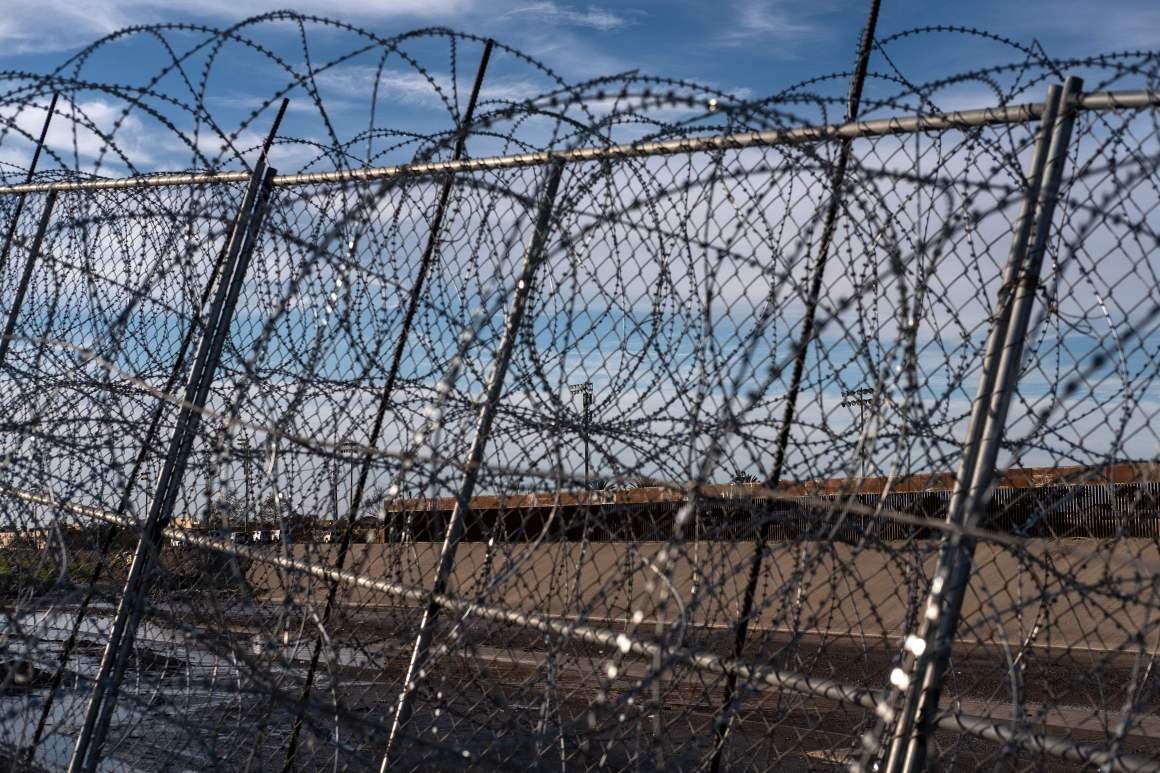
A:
[380,160,564,772]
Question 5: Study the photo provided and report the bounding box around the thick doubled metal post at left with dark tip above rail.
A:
[68,100,288,773]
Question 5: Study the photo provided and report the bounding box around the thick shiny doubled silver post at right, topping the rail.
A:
[884,78,1082,773]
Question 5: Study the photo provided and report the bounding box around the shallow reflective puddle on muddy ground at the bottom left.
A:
[0,605,403,773]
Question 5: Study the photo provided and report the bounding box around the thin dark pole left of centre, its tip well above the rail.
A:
[282,38,495,772]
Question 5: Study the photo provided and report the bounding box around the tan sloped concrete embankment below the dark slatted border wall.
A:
[248,540,1160,651]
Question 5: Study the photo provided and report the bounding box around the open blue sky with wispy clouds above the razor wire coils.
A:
[0,0,1160,116]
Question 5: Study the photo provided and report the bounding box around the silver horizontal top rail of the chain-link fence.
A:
[0,89,1160,194]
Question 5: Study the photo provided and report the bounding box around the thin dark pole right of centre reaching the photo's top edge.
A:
[709,0,882,773]
